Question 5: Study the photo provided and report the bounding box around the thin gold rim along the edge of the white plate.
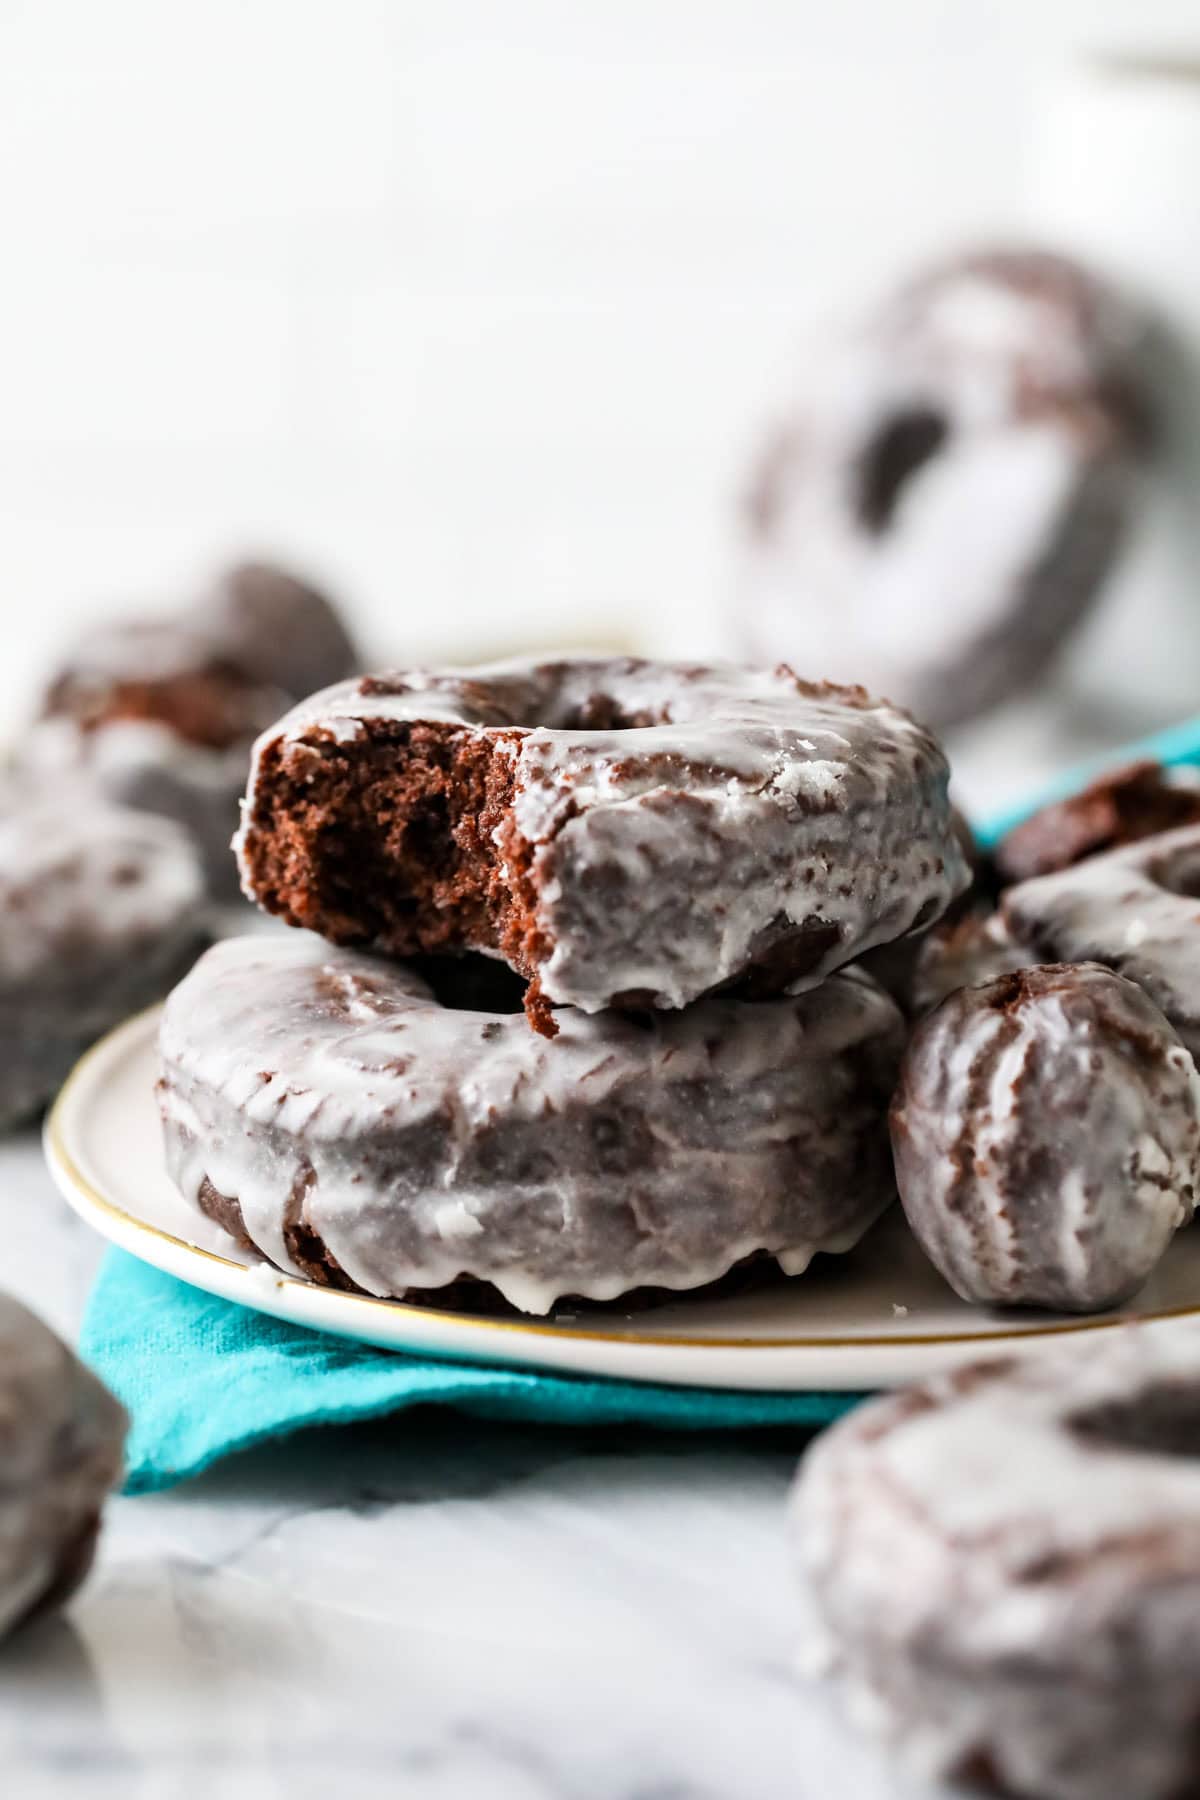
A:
[43,1006,1200,1350]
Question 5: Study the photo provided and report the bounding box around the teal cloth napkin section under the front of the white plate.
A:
[79,1249,860,1494]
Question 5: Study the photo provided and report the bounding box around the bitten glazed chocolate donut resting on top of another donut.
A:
[239,659,968,1030]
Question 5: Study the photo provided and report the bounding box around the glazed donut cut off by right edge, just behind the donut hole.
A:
[1000,824,1200,1057]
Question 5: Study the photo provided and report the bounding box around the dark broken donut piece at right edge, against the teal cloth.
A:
[995,761,1200,887]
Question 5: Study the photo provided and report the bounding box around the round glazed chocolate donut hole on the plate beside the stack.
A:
[892,963,1200,1312]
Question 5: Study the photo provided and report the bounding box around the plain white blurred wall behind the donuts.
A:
[0,0,1200,738]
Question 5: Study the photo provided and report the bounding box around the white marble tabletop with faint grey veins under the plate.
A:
[0,1136,964,1800]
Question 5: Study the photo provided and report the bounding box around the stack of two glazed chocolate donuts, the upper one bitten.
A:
[160,659,968,1312]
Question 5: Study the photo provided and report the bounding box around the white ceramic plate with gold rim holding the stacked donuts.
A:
[45,1010,1200,1390]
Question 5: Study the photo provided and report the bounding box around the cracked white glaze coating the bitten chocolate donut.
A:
[239,659,968,1012]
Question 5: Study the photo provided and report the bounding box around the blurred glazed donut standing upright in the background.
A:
[732,250,1151,725]
